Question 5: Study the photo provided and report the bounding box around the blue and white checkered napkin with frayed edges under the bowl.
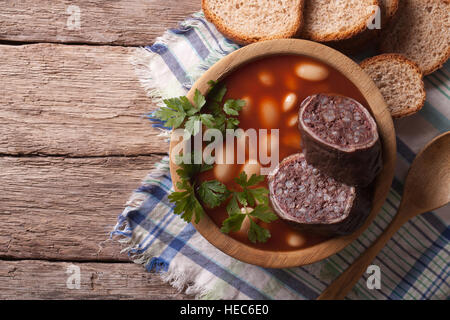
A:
[113,13,450,299]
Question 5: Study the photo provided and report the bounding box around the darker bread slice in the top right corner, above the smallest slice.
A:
[380,0,450,75]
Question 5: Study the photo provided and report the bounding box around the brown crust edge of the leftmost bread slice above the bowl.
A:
[202,0,304,45]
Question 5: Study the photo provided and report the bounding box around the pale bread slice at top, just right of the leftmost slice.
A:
[301,0,378,42]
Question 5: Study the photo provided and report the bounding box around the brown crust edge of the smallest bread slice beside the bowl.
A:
[359,53,426,119]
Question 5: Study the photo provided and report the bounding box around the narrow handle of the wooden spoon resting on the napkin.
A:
[317,210,406,300]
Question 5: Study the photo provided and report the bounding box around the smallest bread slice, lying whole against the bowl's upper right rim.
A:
[360,54,426,118]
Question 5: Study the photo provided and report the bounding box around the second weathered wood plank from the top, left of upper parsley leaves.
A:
[0,43,168,156]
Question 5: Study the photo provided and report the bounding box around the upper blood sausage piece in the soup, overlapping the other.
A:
[299,94,382,186]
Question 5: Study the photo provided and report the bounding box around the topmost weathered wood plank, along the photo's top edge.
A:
[0,0,201,46]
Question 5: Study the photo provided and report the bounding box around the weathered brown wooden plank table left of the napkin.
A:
[0,0,200,299]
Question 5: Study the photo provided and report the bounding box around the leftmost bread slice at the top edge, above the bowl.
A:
[202,0,303,44]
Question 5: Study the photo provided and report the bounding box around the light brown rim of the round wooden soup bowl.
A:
[170,39,396,268]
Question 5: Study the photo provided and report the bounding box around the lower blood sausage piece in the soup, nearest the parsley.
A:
[268,153,371,235]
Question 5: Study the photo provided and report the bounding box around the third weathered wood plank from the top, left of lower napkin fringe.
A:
[0,156,165,261]
